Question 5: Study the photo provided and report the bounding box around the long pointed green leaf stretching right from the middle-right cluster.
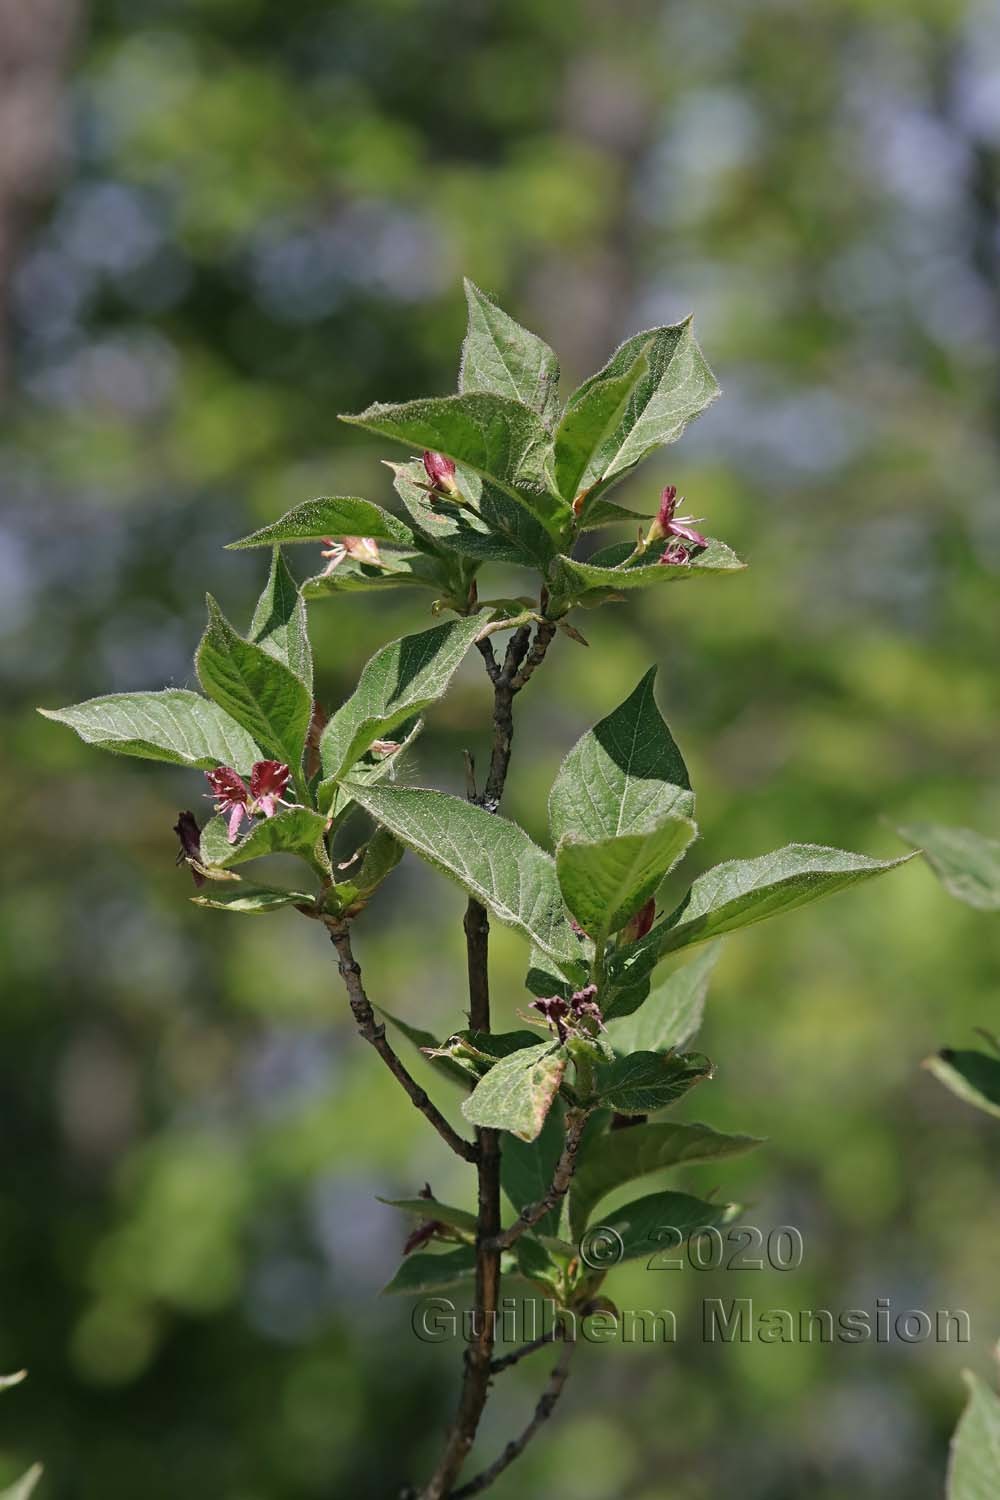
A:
[650,845,915,954]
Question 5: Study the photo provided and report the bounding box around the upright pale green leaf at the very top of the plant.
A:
[459,278,559,428]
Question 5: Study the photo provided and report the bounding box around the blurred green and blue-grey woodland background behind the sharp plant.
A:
[0,0,1000,1500]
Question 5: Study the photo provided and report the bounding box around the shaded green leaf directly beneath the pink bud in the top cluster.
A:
[388,459,555,572]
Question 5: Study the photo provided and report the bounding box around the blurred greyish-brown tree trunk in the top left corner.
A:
[0,0,81,390]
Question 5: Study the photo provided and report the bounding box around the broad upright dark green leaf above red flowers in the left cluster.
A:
[195,596,312,782]
